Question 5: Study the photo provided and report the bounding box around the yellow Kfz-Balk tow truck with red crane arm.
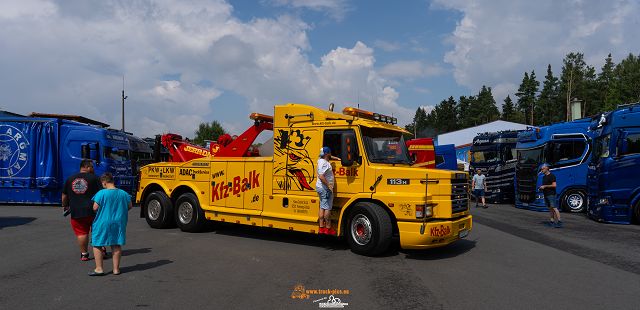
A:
[136,103,472,255]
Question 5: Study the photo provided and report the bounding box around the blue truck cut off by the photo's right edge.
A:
[587,103,640,224]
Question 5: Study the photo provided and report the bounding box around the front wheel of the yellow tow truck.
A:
[345,202,393,256]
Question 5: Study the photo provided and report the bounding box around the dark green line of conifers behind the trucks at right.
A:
[405,52,640,138]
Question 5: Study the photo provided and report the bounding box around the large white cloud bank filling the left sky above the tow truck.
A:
[0,0,412,136]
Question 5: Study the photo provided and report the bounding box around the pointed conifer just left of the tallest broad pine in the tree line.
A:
[535,65,564,125]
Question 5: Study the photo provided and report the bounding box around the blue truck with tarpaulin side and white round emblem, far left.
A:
[0,114,134,204]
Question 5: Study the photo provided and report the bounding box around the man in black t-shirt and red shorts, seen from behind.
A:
[62,159,102,261]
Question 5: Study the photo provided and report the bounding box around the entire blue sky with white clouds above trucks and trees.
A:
[0,0,640,136]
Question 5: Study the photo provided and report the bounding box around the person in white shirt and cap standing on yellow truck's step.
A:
[316,146,336,235]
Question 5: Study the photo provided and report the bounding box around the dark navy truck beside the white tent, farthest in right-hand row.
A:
[469,130,519,203]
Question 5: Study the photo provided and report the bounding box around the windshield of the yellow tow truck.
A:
[362,127,410,165]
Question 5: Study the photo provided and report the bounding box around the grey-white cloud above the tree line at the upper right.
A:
[432,0,640,106]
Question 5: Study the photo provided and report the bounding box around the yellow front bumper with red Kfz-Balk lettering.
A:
[398,215,472,249]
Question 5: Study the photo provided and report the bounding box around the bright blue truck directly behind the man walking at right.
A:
[515,118,593,212]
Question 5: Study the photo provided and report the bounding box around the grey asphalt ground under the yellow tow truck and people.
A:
[0,205,640,309]
